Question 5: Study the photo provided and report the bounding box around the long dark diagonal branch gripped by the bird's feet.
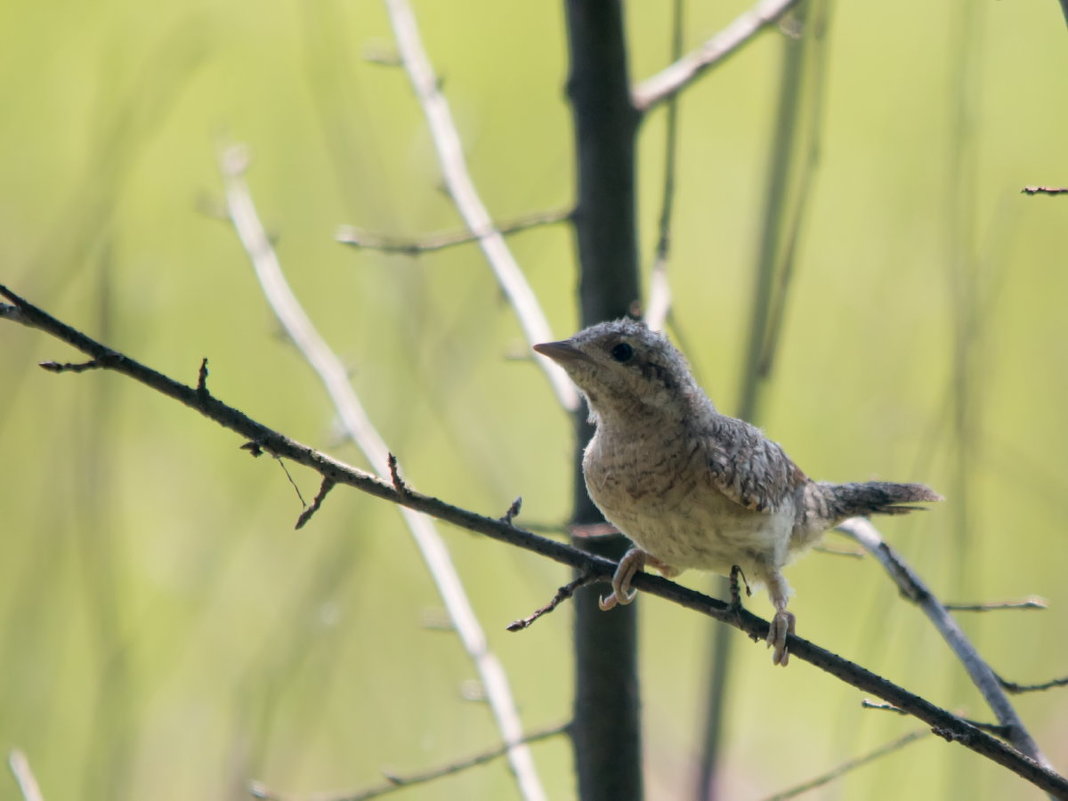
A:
[6,285,1068,799]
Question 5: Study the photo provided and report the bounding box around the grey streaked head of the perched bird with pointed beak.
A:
[534,319,704,423]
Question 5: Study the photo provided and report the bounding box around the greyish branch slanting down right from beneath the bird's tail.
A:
[838,517,1049,767]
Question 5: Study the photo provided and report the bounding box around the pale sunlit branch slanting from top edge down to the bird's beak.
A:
[386,0,579,411]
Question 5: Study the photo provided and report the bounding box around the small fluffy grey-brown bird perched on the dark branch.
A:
[533,318,943,665]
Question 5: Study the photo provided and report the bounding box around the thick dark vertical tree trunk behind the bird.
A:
[566,0,643,801]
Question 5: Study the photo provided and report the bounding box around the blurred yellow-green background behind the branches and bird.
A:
[0,0,1068,799]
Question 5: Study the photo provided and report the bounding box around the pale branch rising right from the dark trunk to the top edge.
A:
[633,0,798,111]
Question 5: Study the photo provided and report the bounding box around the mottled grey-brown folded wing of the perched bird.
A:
[704,414,807,512]
